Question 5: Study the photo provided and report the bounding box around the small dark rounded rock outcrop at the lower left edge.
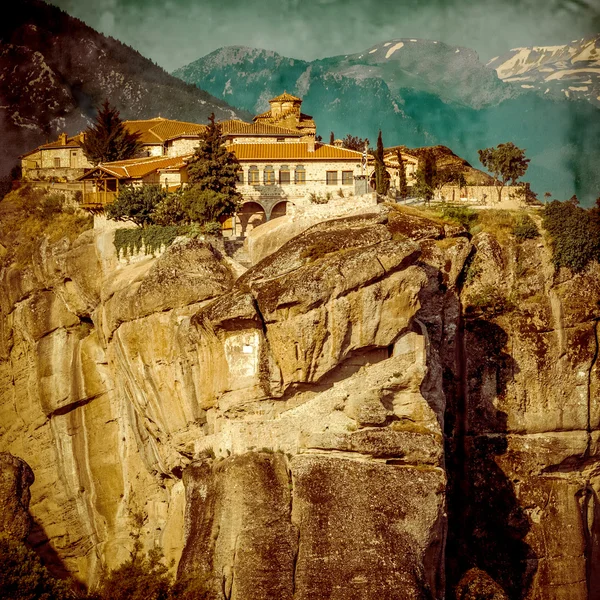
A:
[0,452,34,540]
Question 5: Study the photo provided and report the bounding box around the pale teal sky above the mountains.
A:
[52,0,600,71]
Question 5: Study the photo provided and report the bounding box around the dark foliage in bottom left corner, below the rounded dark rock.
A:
[0,534,81,600]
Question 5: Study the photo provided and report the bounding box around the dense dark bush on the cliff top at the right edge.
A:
[543,200,600,273]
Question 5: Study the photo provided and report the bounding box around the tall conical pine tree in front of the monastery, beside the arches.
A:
[182,113,242,222]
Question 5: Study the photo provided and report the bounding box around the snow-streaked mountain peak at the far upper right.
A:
[487,34,600,106]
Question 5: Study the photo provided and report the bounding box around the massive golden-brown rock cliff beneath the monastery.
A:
[0,207,600,600]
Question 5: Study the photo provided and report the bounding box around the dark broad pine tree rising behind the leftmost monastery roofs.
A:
[81,100,142,165]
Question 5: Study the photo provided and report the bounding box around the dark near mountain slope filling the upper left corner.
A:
[0,0,249,174]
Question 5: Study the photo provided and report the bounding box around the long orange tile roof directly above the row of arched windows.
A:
[229,142,362,161]
